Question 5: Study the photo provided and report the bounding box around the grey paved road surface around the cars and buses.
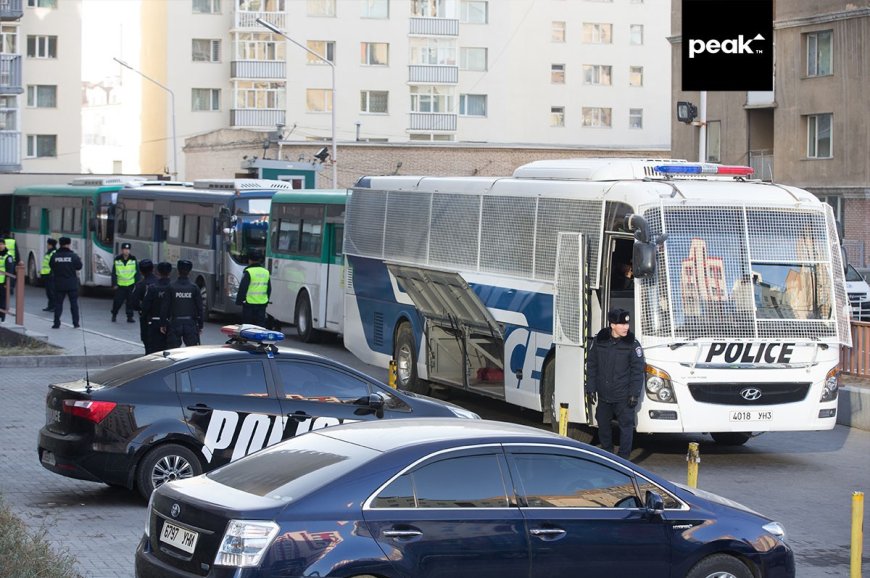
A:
[0,290,870,578]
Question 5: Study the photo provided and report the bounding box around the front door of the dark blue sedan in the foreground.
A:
[508,446,671,578]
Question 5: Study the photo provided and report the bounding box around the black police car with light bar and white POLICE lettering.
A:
[38,325,478,498]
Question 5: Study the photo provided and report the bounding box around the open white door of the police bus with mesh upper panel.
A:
[553,233,590,423]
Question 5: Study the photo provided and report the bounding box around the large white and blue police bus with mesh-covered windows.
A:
[344,159,851,444]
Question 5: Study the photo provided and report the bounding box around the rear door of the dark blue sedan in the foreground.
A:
[363,447,529,578]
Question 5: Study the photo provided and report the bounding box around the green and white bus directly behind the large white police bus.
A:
[266,189,348,342]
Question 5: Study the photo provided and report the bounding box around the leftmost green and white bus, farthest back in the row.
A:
[12,177,136,287]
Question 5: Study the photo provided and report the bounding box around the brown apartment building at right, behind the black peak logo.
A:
[671,0,870,267]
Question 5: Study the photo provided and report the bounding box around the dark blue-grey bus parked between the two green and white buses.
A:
[115,179,291,313]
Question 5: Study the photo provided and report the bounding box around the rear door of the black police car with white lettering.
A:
[176,356,287,470]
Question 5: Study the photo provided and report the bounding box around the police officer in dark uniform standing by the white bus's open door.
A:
[586,309,646,459]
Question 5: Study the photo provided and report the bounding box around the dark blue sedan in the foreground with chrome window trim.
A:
[136,419,795,578]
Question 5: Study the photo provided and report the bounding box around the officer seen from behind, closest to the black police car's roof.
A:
[160,259,203,349]
